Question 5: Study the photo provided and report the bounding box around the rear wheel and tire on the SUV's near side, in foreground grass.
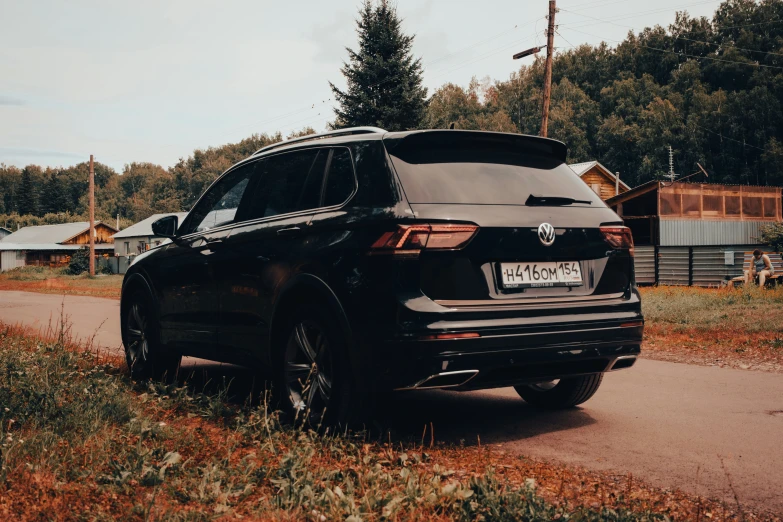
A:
[273,305,357,429]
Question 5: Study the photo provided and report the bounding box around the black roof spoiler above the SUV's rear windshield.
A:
[383,130,568,162]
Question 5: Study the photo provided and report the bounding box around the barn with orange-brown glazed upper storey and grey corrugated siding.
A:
[606,181,781,286]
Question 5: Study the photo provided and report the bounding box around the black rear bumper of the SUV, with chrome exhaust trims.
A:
[371,297,644,390]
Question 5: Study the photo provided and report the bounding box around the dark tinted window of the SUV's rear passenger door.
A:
[250,149,328,218]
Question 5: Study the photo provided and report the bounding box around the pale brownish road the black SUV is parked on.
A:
[0,292,783,512]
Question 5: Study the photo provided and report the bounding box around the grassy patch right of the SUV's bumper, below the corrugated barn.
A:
[641,285,783,371]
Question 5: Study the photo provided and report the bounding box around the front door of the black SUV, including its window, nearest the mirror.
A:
[157,164,255,358]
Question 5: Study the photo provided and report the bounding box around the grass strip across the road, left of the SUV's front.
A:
[0,266,123,299]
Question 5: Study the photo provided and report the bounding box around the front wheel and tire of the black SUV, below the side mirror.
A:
[122,291,182,381]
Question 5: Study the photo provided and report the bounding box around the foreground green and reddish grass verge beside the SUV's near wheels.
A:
[0,325,755,522]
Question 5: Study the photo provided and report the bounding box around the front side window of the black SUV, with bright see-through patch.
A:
[181,163,255,235]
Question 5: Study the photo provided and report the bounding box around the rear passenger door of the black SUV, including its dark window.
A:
[216,148,330,362]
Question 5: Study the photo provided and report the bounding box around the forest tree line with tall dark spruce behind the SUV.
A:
[0,0,783,228]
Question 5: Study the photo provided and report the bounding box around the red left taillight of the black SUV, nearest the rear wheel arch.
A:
[372,224,478,253]
